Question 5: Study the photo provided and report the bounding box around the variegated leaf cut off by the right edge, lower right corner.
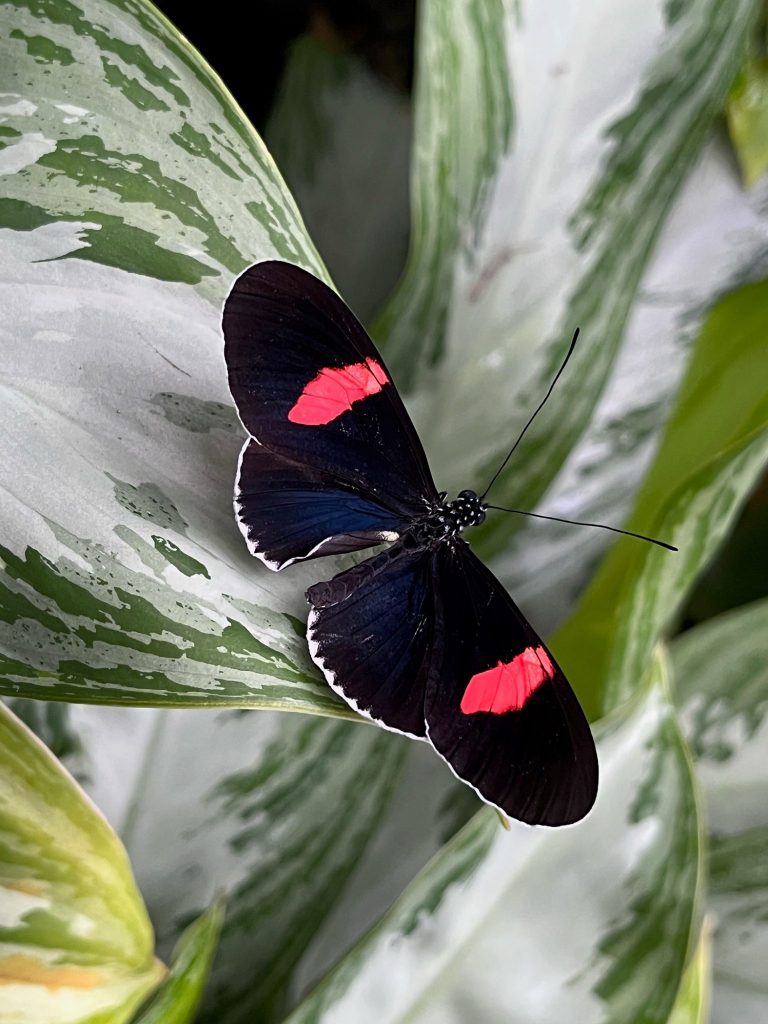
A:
[673,601,768,1024]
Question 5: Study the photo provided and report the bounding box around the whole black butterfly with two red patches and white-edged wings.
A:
[223,261,598,825]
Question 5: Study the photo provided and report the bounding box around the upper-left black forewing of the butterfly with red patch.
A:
[223,261,436,507]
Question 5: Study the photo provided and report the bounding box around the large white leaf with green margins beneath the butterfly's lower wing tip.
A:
[289,662,700,1024]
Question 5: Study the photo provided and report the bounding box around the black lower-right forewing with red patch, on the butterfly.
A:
[425,540,598,825]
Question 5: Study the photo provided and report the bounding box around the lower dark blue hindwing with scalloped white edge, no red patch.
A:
[307,542,434,738]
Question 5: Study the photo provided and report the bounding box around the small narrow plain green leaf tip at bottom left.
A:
[134,901,224,1024]
